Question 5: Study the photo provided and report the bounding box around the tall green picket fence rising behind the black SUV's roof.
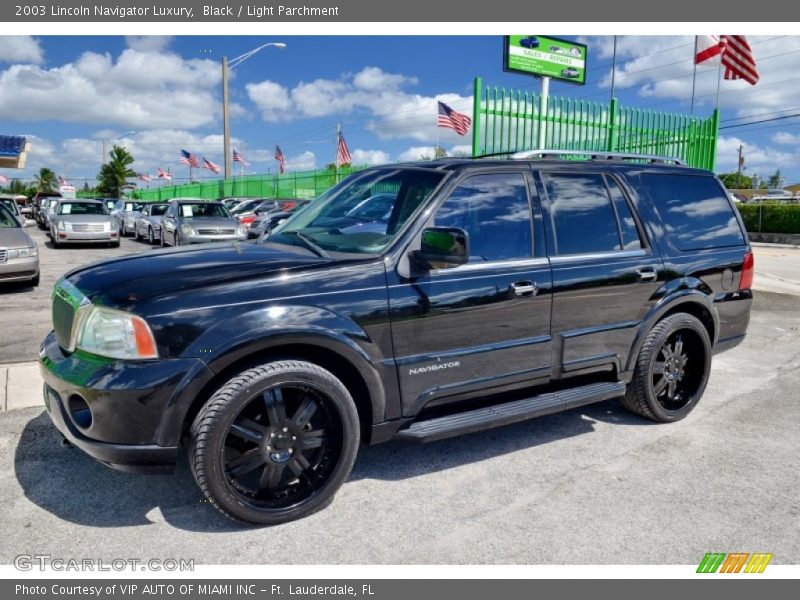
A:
[472,77,719,169]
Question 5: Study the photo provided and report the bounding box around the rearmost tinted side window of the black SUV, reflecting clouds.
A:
[641,175,745,250]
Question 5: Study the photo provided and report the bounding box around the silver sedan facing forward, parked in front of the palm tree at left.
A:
[50,199,119,248]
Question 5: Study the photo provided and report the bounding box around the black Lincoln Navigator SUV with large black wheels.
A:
[40,152,753,523]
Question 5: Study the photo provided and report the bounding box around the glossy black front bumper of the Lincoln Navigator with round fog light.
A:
[39,332,210,473]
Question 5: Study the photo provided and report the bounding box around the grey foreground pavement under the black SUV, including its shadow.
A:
[0,292,800,564]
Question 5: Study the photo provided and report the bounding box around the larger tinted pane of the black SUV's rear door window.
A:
[542,173,622,254]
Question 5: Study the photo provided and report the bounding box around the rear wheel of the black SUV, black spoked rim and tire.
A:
[623,313,711,423]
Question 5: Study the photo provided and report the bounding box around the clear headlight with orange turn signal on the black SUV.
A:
[77,306,158,359]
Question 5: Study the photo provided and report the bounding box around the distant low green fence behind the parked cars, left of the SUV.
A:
[137,166,366,200]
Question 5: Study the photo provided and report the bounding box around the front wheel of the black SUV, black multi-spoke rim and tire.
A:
[188,360,360,525]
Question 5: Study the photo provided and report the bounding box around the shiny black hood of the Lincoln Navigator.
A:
[66,242,330,310]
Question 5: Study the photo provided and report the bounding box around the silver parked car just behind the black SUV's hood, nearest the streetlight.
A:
[161,198,247,246]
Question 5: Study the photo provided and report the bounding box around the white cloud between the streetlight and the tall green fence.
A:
[245,67,472,143]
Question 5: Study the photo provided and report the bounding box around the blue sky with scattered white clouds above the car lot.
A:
[0,32,800,184]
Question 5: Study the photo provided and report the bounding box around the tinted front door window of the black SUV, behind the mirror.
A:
[434,173,532,262]
